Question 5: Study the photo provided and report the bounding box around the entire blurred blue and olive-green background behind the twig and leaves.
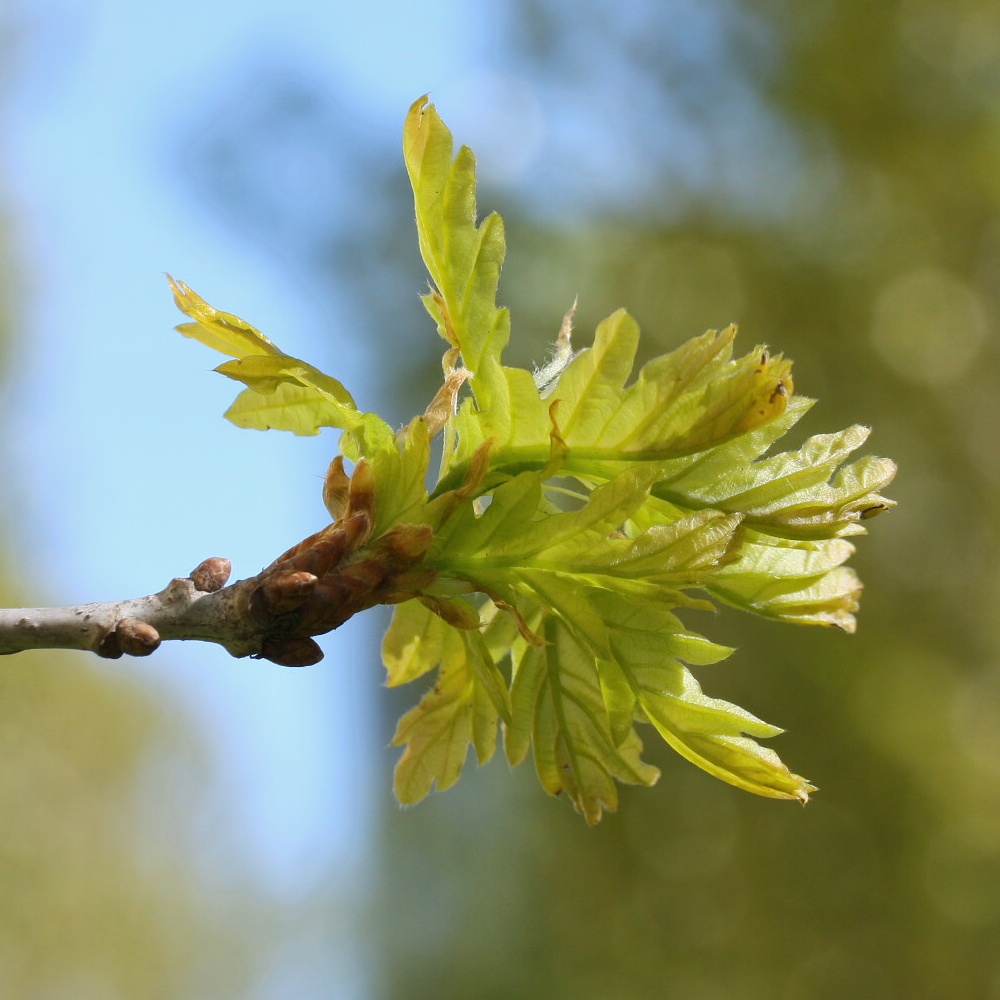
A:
[0,0,1000,1000]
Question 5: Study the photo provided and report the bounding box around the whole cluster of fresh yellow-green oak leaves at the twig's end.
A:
[173,99,895,823]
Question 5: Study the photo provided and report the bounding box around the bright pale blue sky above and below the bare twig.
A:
[3,0,508,996]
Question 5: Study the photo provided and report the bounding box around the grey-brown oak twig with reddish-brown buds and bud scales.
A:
[0,496,433,667]
